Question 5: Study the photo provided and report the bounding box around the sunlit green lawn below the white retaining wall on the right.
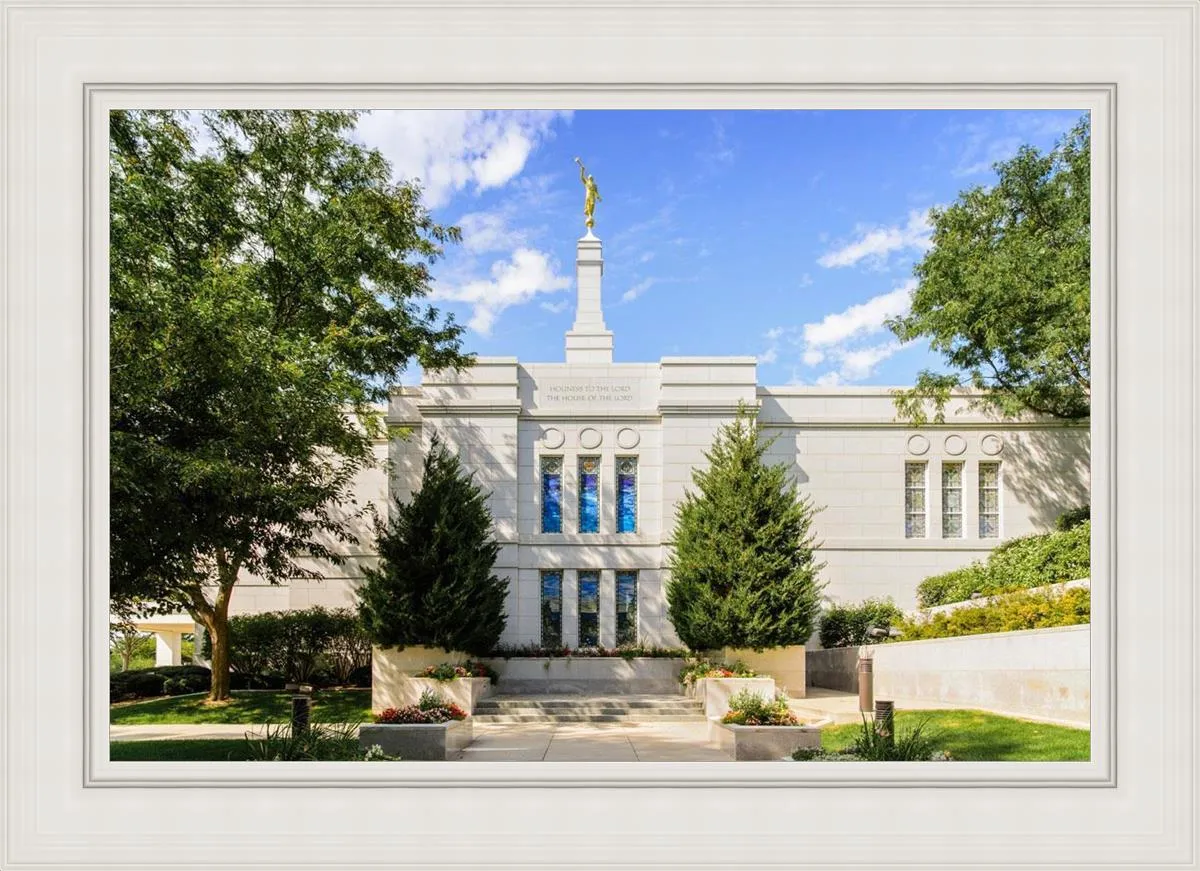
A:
[821,710,1091,762]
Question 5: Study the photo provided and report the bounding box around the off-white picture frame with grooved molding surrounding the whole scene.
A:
[0,0,1200,869]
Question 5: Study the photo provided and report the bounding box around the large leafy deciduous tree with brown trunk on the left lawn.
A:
[109,112,468,701]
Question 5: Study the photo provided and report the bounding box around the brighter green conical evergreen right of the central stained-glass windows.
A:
[667,407,824,650]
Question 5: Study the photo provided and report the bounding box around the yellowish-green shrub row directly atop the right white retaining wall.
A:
[898,587,1092,641]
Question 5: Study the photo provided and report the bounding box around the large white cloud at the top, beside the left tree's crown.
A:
[358,109,571,208]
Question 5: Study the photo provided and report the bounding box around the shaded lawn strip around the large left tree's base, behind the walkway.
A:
[108,690,371,724]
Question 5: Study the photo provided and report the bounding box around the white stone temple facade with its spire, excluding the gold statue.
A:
[187,234,1088,647]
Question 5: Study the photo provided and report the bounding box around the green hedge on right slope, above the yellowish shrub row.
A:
[917,519,1092,608]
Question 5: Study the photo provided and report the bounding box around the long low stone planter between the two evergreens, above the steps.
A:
[484,656,684,696]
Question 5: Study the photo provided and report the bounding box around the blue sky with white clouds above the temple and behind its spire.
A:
[359,110,1081,385]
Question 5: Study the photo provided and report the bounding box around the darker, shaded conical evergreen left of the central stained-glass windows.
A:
[359,437,508,655]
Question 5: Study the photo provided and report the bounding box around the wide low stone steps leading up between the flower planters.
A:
[472,695,704,726]
